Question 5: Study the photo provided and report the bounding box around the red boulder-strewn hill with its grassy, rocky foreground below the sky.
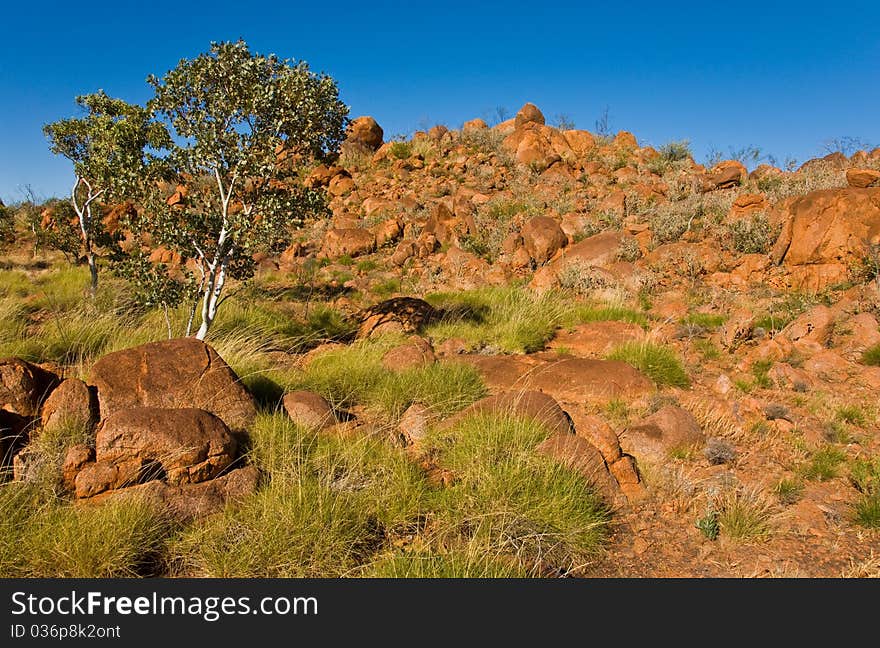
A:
[0,104,880,576]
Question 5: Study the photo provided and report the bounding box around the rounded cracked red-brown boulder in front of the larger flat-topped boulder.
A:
[74,407,238,497]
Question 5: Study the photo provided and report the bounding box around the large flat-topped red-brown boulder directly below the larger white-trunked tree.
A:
[89,338,257,431]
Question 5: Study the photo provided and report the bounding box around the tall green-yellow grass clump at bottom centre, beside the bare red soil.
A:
[428,414,608,574]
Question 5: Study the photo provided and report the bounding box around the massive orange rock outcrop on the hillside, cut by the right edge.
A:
[771,187,880,288]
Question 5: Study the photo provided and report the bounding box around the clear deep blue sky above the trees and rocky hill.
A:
[0,0,880,202]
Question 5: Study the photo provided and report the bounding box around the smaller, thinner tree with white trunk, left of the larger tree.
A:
[43,90,168,295]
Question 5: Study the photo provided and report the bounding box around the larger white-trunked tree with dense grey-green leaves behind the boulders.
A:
[140,41,348,339]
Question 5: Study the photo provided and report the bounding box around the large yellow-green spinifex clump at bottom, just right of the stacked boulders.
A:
[173,414,426,577]
